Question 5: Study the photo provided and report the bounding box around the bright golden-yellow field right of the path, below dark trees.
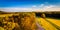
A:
[37,18,60,30]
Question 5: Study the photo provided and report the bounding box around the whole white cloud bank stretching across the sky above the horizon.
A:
[0,4,60,12]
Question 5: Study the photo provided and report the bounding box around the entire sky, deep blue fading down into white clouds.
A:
[0,0,60,11]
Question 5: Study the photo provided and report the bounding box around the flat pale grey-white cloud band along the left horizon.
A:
[0,8,38,12]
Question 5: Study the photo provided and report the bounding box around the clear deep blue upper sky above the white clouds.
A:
[0,0,60,8]
